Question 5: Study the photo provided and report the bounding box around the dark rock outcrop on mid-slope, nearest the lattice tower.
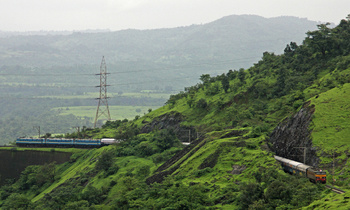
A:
[141,112,197,141]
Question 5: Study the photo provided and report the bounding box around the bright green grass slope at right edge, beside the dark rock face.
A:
[306,83,350,209]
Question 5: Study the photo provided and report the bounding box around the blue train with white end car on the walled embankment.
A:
[16,138,120,148]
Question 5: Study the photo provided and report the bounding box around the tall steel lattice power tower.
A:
[94,56,111,128]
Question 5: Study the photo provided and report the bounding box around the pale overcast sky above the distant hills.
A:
[0,0,350,31]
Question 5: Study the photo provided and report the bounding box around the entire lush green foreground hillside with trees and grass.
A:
[0,16,350,209]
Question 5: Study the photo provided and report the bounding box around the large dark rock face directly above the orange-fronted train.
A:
[269,103,319,166]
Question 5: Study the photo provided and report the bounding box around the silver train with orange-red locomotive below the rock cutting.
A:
[274,155,327,184]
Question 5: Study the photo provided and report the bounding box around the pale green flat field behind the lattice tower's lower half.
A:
[53,106,159,120]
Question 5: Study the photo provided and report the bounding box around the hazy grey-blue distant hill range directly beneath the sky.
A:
[0,15,317,89]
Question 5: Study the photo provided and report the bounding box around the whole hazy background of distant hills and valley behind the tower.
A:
[0,16,316,144]
